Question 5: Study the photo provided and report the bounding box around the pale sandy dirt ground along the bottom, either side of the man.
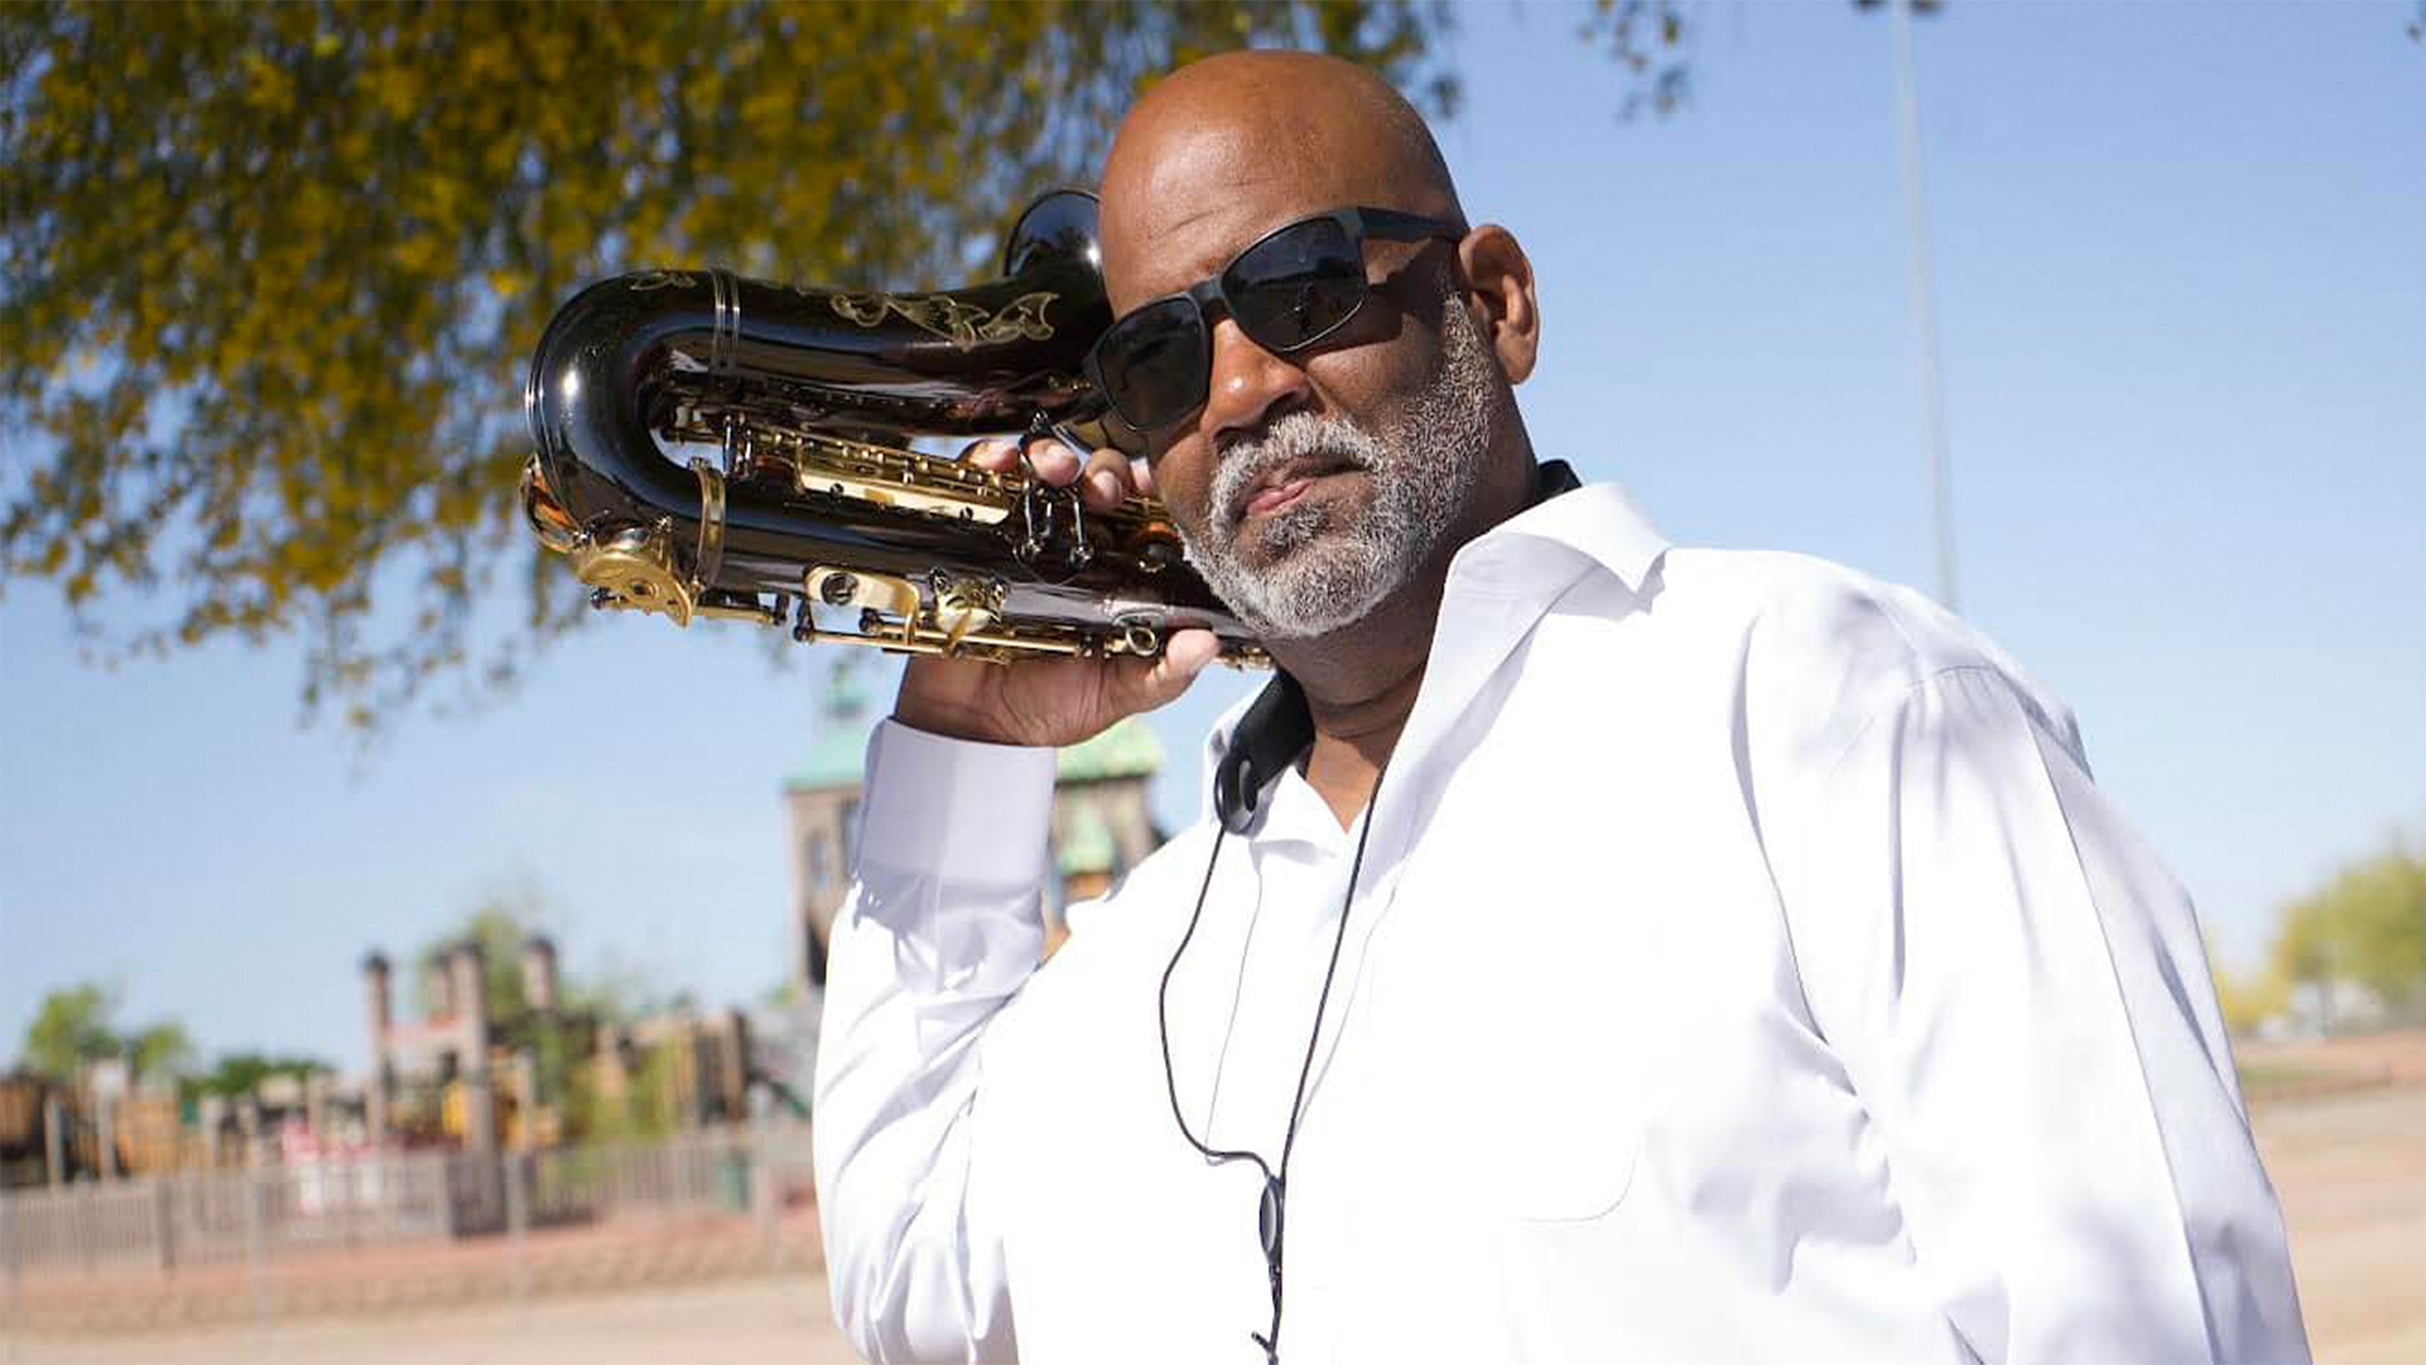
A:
[0,1061,2426,1365]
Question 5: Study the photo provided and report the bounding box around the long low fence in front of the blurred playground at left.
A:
[0,1123,808,1280]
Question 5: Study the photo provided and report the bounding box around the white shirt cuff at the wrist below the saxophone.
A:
[859,720,1055,885]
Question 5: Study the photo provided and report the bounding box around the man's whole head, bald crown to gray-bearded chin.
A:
[1099,51,1538,669]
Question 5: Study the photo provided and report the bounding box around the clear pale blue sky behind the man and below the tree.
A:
[0,0,2426,1067]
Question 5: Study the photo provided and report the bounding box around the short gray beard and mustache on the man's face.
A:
[1189,298,1494,640]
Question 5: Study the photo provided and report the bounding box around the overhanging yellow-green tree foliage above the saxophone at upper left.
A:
[0,0,1453,725]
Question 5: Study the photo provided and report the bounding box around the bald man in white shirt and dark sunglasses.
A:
[818,53,2307,1363]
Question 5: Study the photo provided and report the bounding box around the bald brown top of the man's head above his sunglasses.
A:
[1101,51,1465,310]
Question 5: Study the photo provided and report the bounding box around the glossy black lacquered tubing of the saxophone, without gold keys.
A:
[524,192,1249,642]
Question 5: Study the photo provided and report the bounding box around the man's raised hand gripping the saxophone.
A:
[893,441,1220,747]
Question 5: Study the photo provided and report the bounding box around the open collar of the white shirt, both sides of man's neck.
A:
[1203,461,1669,834]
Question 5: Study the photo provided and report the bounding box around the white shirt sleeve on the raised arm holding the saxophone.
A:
[815,720,1053,1360]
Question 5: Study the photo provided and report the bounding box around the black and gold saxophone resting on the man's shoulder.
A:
[522,189,1271,667]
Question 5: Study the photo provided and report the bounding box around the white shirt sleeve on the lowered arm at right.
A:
[1773,667,2307,1363]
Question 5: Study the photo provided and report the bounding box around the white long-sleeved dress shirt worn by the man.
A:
[815,475,2307,1365]
